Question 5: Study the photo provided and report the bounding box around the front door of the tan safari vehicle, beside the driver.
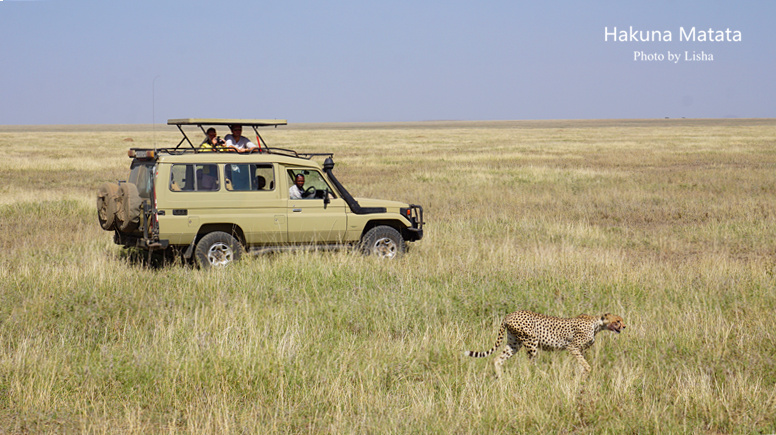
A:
[284,168,347,244]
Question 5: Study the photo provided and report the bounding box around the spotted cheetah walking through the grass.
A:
[464,310,625,378]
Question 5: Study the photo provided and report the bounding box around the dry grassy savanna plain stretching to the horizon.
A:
[0,120,776,434]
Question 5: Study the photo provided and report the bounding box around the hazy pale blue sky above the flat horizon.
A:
[0,0,776,124]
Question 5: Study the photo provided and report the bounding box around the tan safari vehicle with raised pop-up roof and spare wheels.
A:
[97,119,423,267]
